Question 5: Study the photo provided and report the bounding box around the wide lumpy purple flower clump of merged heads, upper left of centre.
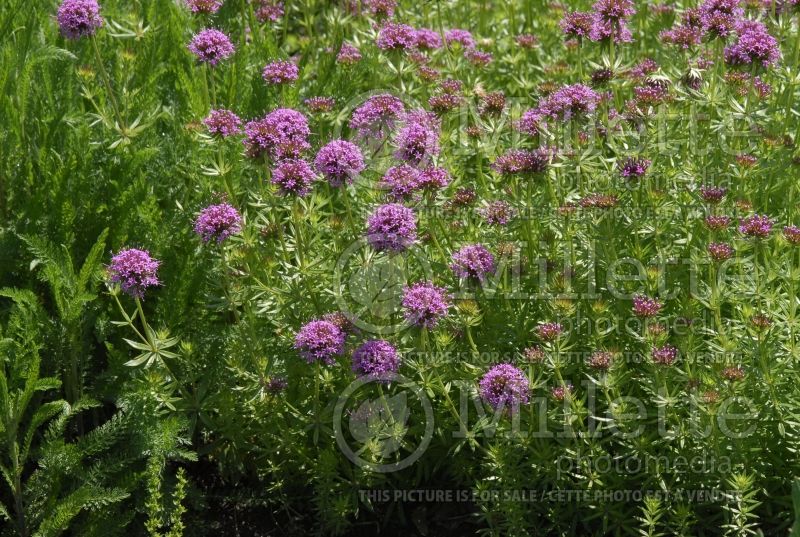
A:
[244,108,311,160]
